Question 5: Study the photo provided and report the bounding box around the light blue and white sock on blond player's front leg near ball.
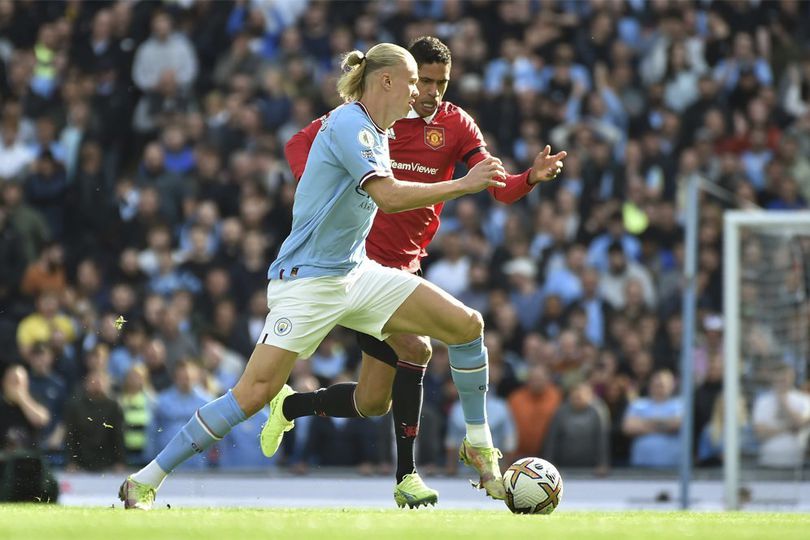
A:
[448,336,492,446]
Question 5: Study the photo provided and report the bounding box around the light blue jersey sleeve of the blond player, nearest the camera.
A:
[330,111,394,186]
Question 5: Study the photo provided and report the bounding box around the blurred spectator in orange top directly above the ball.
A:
[508,364,562,456]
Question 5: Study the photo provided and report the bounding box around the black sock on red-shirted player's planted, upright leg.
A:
[392,360,425,483]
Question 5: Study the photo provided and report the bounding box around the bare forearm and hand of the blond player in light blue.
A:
[362,157,506,214]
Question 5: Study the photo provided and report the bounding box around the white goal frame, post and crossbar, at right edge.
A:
[723,210,810,510]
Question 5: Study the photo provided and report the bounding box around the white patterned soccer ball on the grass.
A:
[503,458,563,514]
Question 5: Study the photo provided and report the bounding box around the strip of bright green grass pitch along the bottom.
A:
[0,505,810,540]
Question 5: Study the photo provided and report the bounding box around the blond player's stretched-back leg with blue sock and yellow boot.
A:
[119,344,298,510]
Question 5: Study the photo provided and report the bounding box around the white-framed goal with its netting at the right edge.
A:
[722,211,810,509]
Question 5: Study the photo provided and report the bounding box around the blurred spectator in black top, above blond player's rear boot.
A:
[65,371,126,471]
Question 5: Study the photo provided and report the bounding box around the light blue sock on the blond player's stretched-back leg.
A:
[155,390,246,473]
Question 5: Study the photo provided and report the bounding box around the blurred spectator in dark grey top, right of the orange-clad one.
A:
[543,383,610,476]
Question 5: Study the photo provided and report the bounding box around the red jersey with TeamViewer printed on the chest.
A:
[284,101,532,272]
